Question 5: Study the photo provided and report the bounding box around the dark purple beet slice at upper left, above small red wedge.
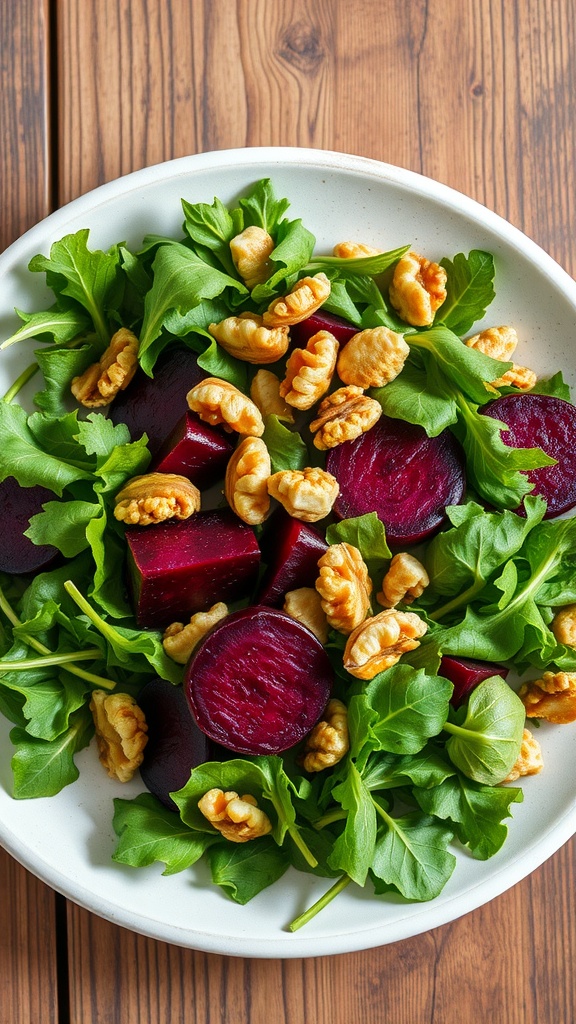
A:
[110,345,208,455]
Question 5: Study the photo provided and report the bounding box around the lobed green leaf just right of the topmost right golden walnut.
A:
[437,249,496,333]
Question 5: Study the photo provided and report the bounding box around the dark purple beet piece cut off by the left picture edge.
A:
[0,476,59,575]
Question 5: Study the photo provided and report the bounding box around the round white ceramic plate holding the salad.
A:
[0,148,576,957]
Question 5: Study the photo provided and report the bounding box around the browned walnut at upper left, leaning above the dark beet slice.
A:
[71,327,139,409]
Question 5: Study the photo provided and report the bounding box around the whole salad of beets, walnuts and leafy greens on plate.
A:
[0,179,576,929]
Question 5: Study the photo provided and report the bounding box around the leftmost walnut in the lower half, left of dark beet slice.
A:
[90,690,148,782]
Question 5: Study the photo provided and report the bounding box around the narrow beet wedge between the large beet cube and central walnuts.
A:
[258,509,328,605]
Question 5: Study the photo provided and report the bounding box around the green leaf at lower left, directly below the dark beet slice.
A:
[112,793,218,874]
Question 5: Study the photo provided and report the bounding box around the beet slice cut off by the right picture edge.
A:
[482,394,576,519]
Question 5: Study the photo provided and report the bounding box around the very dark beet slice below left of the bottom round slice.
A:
[138,679,222,811]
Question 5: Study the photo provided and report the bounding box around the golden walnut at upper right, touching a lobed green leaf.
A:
[389,252,447,327]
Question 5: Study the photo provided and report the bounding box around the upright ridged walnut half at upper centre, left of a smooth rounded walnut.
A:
[280,331,338,410]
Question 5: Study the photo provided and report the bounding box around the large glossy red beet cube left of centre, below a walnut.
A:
[126,509,260,629]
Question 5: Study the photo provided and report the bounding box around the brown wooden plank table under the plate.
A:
[0,0,576,1024]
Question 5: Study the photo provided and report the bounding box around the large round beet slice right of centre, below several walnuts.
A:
[326,416,464,546]
